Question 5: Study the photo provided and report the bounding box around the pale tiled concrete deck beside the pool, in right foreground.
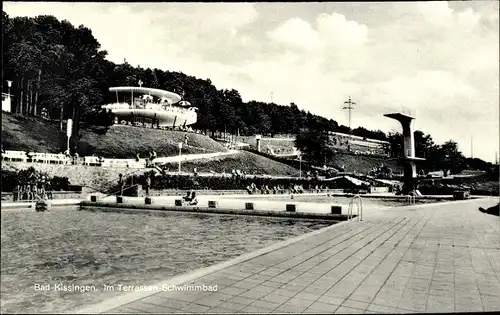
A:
[75,197,500,313]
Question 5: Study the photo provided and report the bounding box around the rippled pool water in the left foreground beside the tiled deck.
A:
[1,210,332,313]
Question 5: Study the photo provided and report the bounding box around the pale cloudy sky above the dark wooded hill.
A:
[3,1,500,162]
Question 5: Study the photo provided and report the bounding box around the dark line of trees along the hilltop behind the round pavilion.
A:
[2,12,496,175]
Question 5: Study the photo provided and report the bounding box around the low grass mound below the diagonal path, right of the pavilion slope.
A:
[167,151,299,176]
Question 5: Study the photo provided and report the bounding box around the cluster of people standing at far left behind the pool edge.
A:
[13,172,53,201]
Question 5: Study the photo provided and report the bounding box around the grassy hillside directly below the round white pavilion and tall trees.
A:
[2,113,227,158]
